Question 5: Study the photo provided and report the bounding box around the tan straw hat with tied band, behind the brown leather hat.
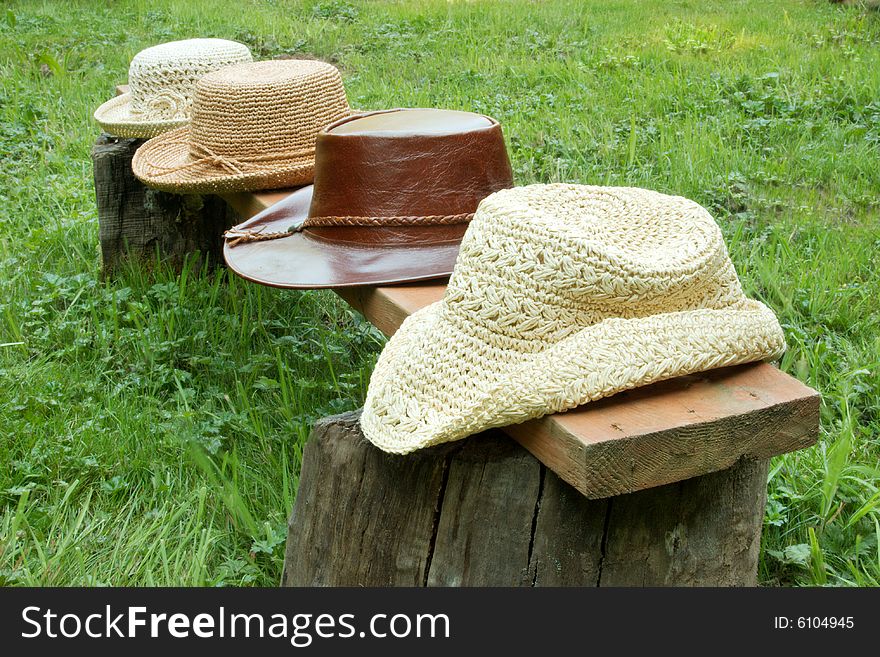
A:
[131,59,351,193]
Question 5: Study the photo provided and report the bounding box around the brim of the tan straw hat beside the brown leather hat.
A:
[131,126,315,194]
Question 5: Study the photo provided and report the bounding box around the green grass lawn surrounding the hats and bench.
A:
[0,0,880,585]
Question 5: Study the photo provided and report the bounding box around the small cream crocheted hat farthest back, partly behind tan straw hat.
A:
[95,39,253,139]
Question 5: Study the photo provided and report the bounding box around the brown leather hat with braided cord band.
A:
[223,109,513,288]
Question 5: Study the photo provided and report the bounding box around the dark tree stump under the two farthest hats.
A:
[92,133,241,274]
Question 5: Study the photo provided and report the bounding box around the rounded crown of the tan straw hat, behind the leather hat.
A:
[190,59,350,159]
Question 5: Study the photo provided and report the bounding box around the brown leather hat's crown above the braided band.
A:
[309,108,513,220]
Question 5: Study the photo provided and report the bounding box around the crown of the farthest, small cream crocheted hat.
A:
[128,39,253,120]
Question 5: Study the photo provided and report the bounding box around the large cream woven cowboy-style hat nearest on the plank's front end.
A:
[361,184,785,454]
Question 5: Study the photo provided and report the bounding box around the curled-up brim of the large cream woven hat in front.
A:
[361,299,785,454]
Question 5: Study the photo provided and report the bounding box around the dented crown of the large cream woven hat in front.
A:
[445,184,743,351]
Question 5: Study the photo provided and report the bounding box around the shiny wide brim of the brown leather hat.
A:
[223,185,467,289]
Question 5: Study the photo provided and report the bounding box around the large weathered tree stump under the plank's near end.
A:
[282,413,768,586]
